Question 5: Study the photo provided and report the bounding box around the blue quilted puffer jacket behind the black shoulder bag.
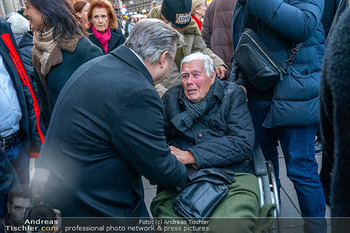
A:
[231,0,325,128]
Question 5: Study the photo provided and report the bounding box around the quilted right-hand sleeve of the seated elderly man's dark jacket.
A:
[188,85,255,169]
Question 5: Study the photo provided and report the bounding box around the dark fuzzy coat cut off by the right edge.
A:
[320,7,350,218]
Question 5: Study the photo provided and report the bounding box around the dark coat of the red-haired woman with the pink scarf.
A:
[87,27,125,54]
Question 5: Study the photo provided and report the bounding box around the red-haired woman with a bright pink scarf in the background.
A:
[87,0,125,54]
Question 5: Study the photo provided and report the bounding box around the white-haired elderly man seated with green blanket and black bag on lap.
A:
[151,53,273,232]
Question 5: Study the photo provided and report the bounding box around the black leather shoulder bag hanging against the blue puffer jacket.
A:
[232,28,302,91]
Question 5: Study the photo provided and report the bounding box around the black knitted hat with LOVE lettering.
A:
[161,0,192,28]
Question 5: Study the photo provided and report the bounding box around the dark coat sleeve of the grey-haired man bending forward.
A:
[112,90,187,189]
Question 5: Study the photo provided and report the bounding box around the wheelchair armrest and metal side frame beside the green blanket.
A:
[252,143,282,232]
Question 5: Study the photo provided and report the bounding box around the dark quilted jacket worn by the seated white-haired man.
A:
[162,79,255,169]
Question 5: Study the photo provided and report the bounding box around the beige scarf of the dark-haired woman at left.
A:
[33,28,57,76]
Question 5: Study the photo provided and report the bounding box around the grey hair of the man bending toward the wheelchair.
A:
[124,19,183,64]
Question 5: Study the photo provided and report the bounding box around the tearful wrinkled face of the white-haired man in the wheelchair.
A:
[181,60,215,103]
